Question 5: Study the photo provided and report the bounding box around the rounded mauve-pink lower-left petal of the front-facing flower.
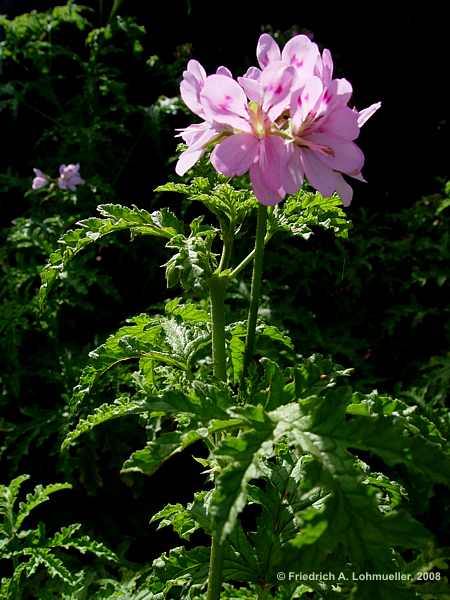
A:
[211,133,259,177]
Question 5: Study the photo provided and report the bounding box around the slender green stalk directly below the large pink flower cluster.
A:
[241,204,267,381]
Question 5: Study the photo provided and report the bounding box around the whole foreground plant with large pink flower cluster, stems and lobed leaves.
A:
[37,34,450,600]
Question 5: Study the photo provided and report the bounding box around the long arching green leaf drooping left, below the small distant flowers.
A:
[39,204,183,306]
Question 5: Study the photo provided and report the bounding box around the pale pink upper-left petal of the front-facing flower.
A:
[200,75,250,131]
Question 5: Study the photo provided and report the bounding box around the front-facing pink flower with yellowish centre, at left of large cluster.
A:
[205,61,294,204]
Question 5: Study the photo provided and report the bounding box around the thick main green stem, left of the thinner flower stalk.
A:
[207,273,227,600]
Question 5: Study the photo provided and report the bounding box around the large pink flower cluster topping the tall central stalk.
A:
[176,33,381,206]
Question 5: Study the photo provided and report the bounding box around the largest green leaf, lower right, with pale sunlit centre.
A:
[210,359,450,581]
